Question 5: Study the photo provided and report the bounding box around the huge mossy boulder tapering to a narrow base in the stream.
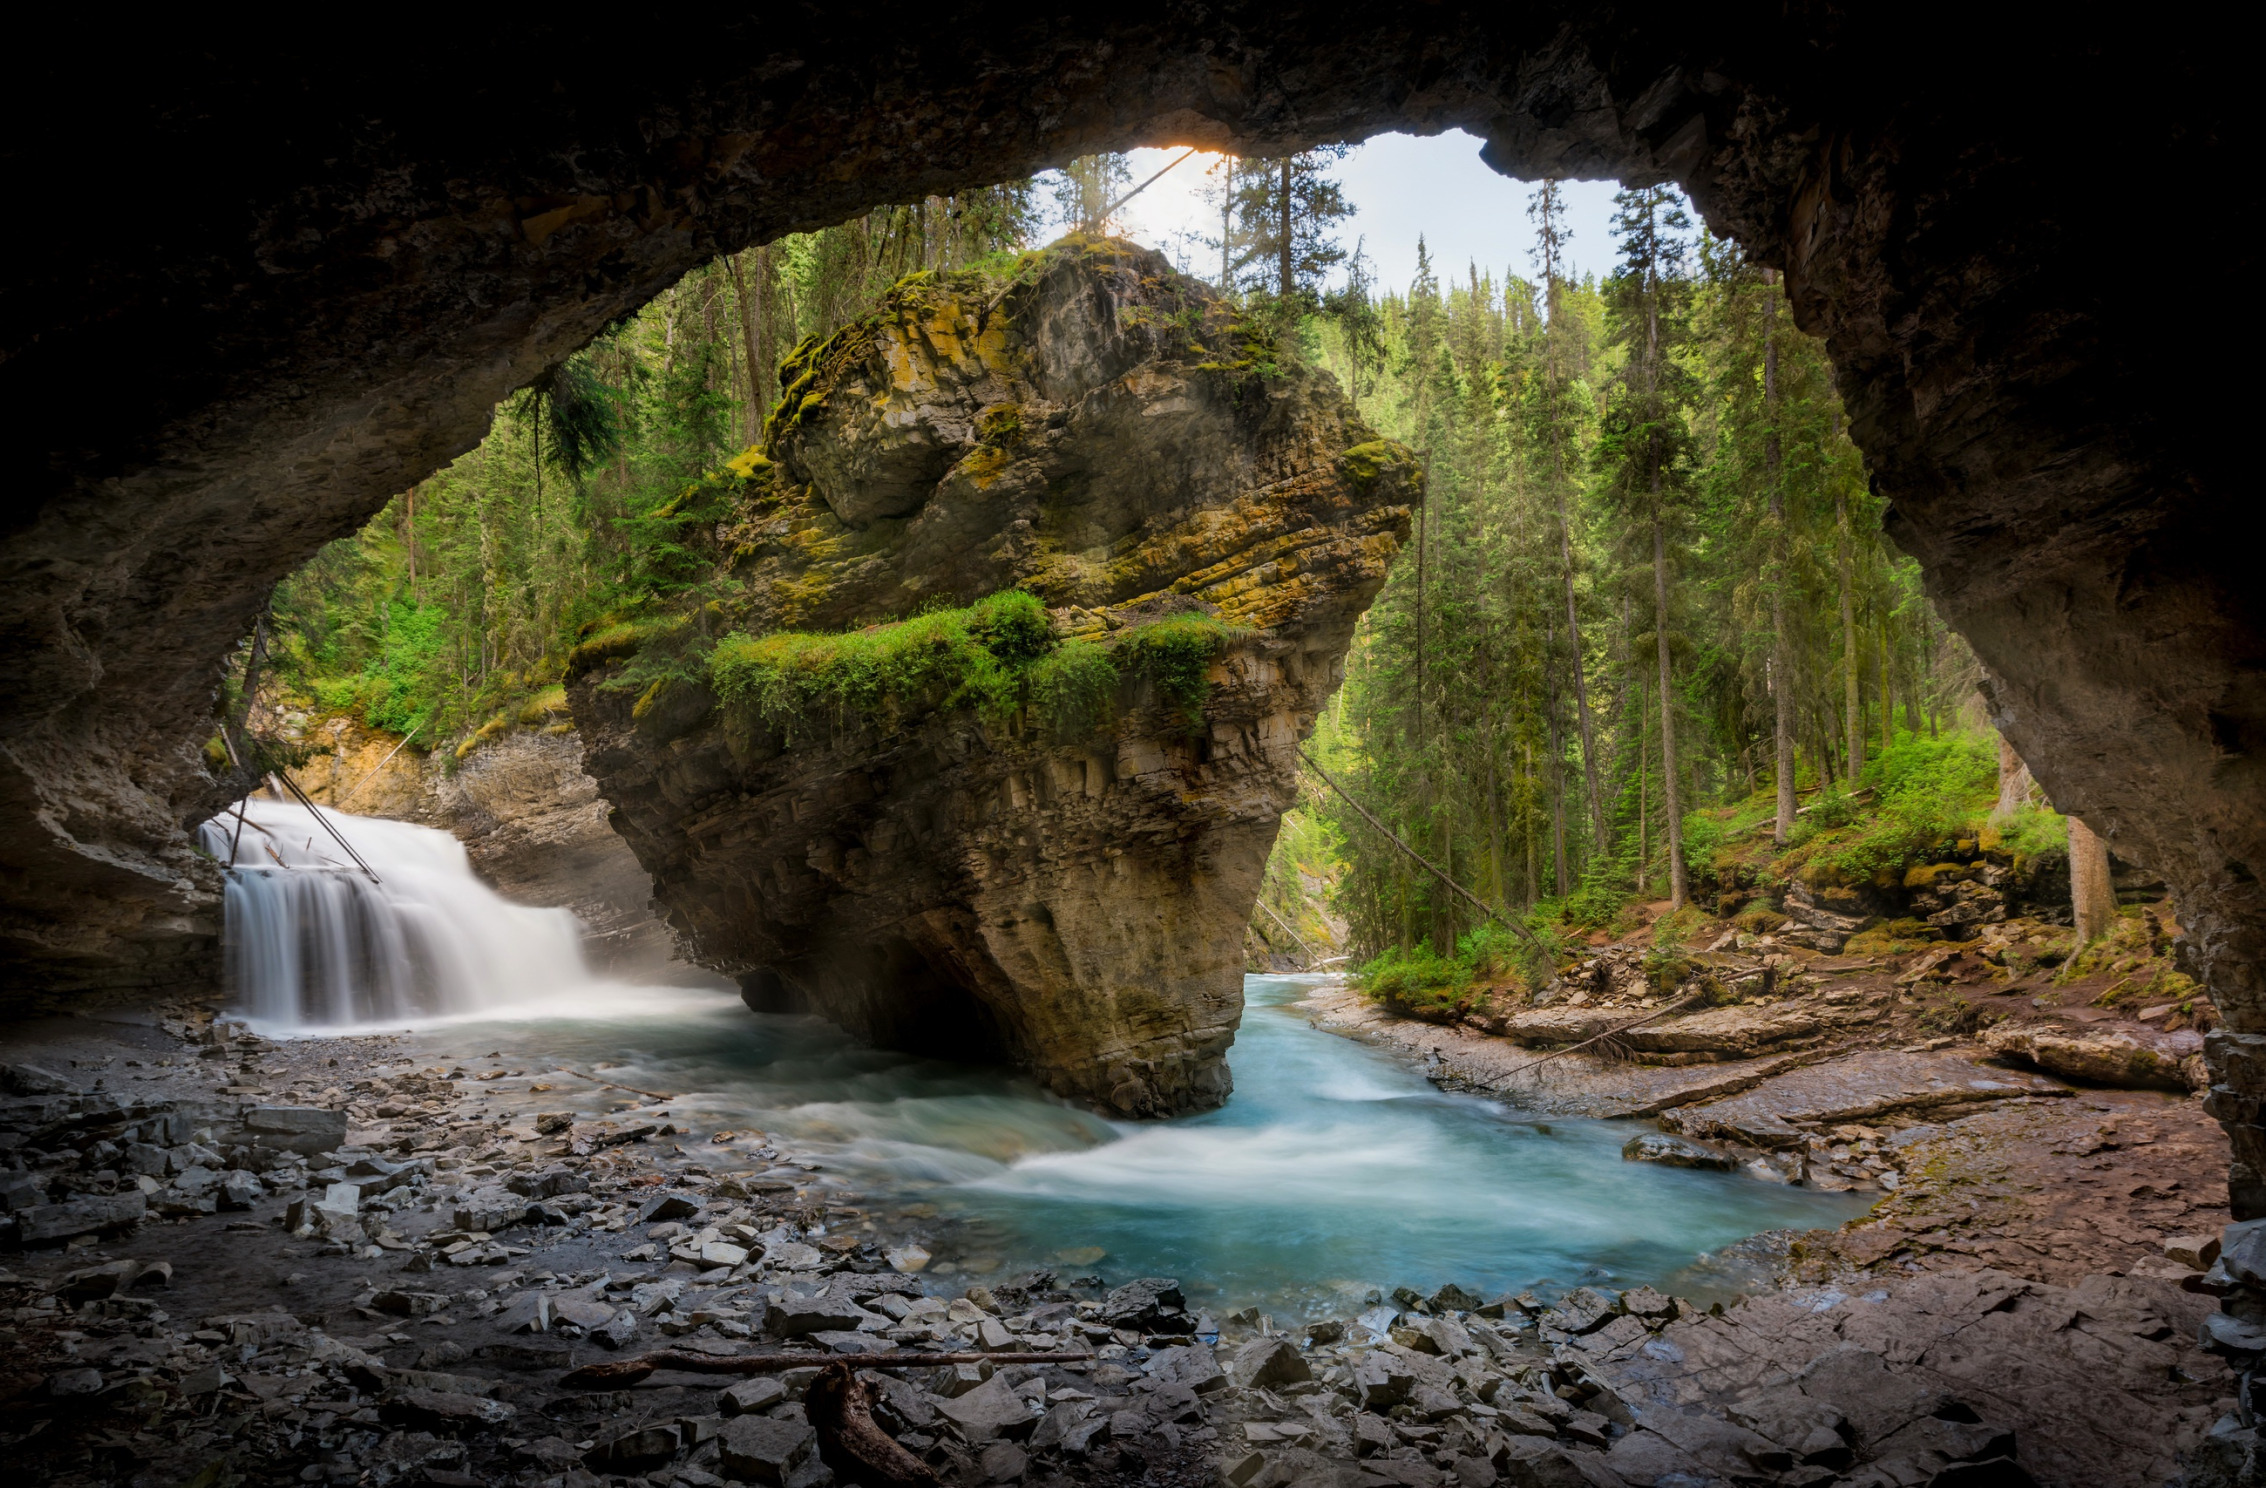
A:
[569,238,1419,1114]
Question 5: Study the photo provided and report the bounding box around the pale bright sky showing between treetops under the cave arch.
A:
[1037,131,1618,292]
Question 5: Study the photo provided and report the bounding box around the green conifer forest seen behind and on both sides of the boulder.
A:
[267,149,2058,983]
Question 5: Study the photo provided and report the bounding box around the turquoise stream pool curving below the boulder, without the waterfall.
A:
[371,976,1865,1316]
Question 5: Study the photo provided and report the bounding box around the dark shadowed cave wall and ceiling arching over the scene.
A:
[0,20,2266,1186]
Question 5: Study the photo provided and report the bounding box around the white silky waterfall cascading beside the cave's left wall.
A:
[199,799,591,1028]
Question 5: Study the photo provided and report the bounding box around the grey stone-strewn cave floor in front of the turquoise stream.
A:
[0,987,2248,1488]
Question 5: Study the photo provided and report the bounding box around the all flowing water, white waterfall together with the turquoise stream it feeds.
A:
[204,802,1865,1316]
